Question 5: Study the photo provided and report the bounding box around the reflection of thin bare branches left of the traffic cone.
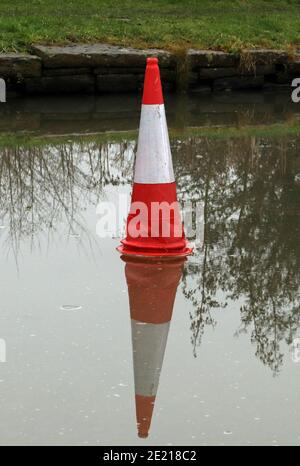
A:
[0,142,134,260]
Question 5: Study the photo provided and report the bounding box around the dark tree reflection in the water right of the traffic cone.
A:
[176,134,300,373]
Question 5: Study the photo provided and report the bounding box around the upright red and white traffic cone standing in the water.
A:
[118,58,192,256]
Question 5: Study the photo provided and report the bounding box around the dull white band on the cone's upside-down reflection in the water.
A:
[131,319,170,396]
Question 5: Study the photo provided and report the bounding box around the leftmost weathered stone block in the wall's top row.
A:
[0,53,41,78]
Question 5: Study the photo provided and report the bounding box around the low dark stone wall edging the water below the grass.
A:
[0,44,300,94]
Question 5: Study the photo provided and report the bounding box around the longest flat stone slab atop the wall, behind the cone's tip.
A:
[32,44,176,68]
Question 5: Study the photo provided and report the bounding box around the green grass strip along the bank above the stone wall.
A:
[0,0,300,52]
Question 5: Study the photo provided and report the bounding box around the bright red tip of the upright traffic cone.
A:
[142,58,164,105]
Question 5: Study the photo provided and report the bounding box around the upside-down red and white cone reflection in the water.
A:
[122,256,185,438]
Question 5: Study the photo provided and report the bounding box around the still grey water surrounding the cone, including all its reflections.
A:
[0,94,300,445]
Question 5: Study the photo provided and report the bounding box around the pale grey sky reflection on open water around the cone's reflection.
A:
[0,231,299,445]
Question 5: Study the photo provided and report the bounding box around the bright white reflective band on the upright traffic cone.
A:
[134,104,175,184]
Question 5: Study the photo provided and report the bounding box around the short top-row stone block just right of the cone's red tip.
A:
[187,49,239,69]
